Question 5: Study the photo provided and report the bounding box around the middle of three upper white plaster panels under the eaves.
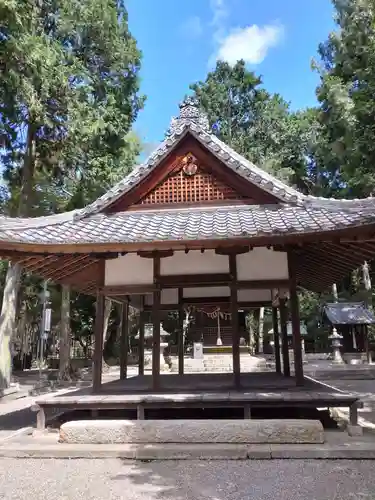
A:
[160,250,229,276]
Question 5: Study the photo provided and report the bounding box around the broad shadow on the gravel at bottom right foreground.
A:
[110,460,374,500]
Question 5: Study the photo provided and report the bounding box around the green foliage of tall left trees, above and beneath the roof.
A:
[0,0,144,352]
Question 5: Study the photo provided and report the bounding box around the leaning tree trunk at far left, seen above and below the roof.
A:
[0,124,36,389]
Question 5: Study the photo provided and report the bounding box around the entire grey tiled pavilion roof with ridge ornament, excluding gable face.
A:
[0,100,375,248]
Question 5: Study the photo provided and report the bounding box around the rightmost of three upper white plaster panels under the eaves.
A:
[237,247,288,281]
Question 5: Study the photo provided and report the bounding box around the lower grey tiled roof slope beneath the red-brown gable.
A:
[0,205,375,246]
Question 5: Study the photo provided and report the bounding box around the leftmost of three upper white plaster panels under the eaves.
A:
[105,253,154,286]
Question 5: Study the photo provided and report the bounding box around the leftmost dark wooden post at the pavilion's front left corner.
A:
[92,260,105,392]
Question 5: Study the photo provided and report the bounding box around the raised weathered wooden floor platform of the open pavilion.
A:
[36,372,358,428]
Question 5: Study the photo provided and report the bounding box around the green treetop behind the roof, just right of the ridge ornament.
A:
[191,61,316,192]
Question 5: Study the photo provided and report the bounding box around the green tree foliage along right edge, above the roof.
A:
[315,0,375,197]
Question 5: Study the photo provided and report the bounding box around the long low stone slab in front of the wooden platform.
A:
[59,420,324,444]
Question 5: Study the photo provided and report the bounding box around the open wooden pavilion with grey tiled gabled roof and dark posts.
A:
[0,98,375,392]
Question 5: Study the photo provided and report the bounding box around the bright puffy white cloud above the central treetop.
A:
[215,23,284,64]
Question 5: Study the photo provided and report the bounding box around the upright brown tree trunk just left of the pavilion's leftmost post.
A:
[59,285,71,380]
